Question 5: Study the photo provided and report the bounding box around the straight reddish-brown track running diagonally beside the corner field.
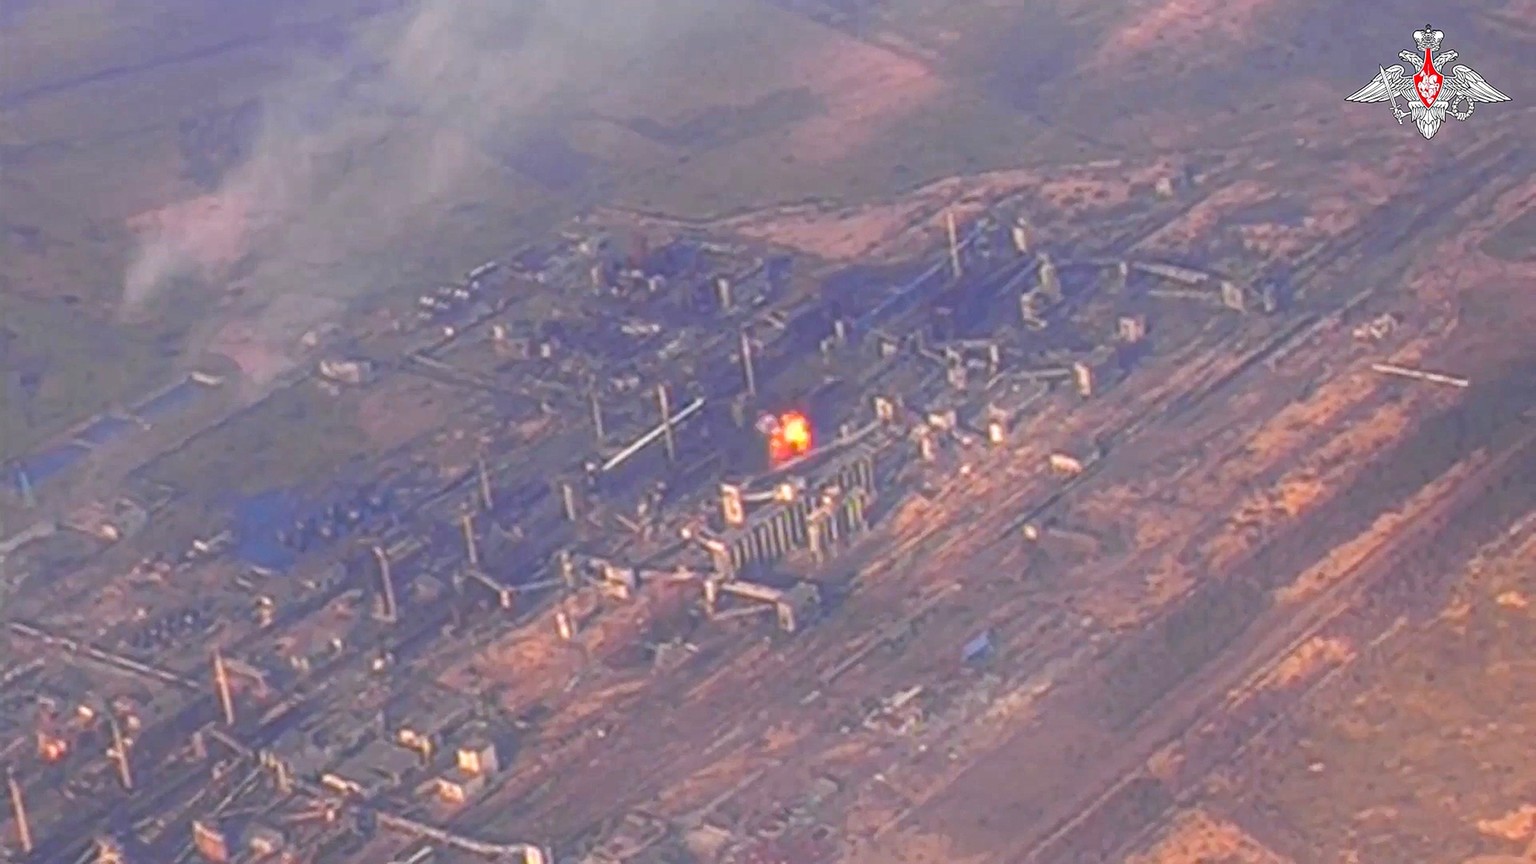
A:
[1011,396,1536,864]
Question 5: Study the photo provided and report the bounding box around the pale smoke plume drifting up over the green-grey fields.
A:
[123,0,730,378]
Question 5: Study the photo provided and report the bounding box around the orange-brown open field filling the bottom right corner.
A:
[1138,518,1536,864]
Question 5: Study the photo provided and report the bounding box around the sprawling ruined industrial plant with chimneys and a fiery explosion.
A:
[0,164,1499,864]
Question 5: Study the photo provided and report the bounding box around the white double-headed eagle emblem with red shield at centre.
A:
[1349,28,1510,138]
